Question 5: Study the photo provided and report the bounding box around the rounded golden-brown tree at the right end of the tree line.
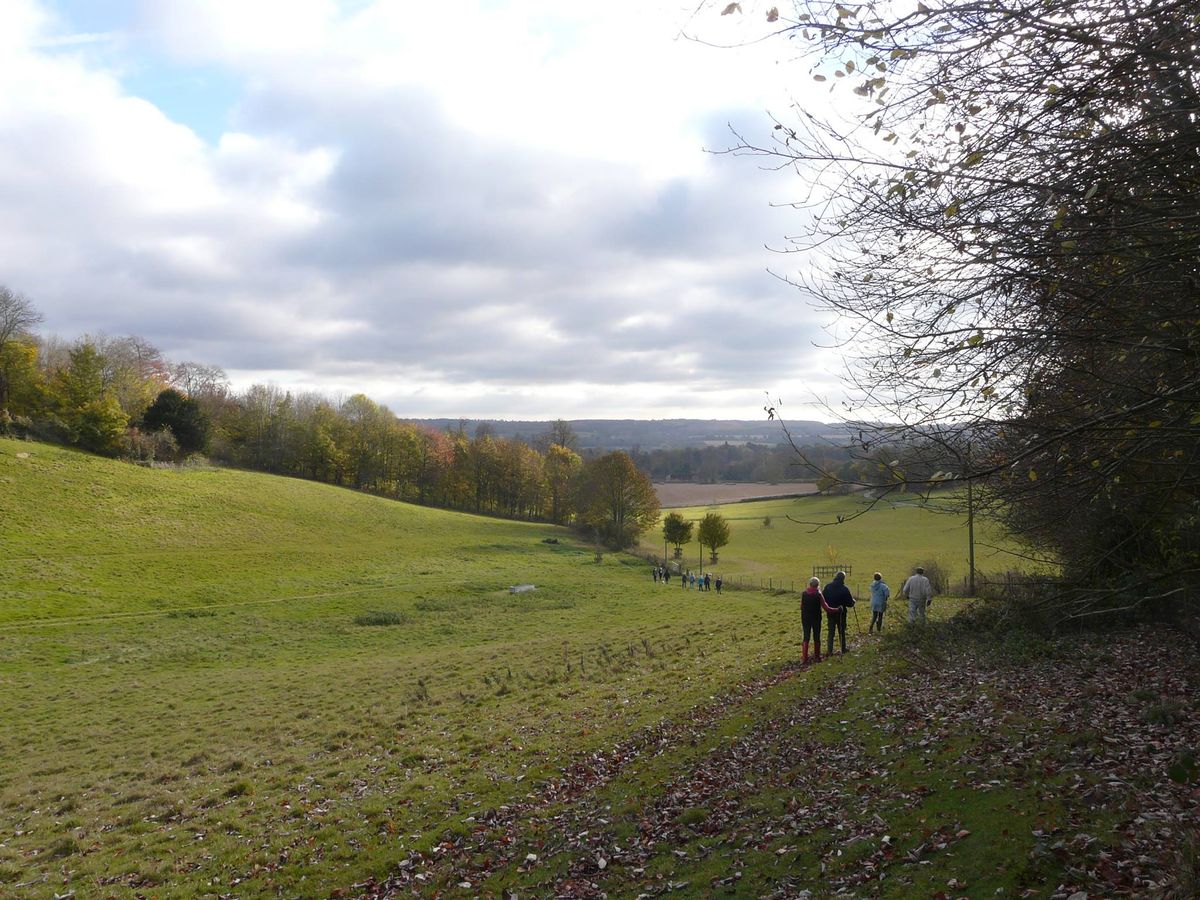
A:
[574,450,659,548]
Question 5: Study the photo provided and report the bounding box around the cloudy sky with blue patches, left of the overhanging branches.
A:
[0,0,840,419]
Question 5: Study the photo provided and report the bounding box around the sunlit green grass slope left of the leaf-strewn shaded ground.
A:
[0,440,811,896]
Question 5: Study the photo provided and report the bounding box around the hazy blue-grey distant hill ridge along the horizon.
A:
[408,419,842,450]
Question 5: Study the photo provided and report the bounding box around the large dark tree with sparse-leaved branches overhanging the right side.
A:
[705,0,1200,614]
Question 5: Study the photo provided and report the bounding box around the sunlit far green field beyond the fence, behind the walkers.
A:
[641,496,1028,590]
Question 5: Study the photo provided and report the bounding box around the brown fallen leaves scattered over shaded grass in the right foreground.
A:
[355,632,1200,900]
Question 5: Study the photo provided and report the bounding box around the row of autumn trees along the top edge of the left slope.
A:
[0,287,659,547]
